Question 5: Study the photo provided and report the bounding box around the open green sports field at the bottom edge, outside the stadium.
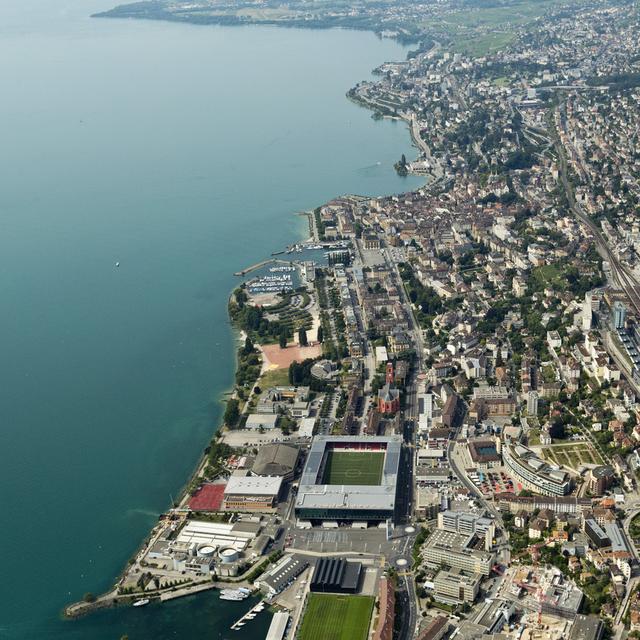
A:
[298,593,374,640]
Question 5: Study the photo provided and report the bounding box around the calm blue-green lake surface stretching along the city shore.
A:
[0,0,420,640]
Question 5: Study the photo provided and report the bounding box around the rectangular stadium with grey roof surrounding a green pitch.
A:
[295,436,402,522]
